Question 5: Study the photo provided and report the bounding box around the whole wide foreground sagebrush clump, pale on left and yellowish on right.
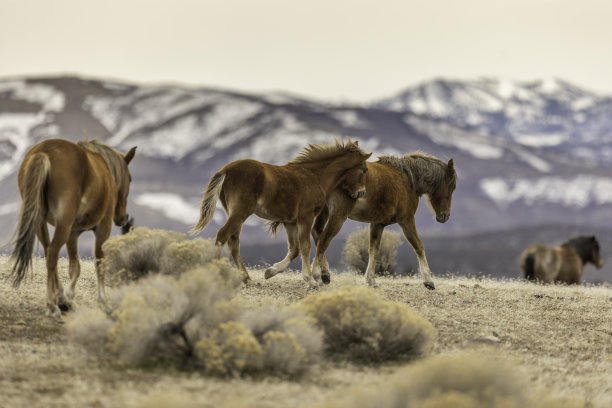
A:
[68,260,322,376]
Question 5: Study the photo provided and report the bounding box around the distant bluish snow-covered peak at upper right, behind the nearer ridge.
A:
[374,79,612,166]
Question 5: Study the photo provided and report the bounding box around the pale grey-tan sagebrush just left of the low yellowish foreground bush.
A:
[68,259,240,365]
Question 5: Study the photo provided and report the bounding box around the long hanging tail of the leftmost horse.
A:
[11,153,51,287]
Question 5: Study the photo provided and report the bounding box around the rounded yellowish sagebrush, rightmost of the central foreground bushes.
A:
[300,286,435,361]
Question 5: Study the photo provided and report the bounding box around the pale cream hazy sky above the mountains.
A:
[0,0,612,102]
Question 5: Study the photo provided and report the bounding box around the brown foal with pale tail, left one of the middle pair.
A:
[192,139,371,287]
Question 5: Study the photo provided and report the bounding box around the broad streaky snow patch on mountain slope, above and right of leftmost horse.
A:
[84,87,263,156]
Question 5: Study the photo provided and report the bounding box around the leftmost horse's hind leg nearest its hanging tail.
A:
[46,223,71,316]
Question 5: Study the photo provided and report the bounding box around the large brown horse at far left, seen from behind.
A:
[12,139,136,315]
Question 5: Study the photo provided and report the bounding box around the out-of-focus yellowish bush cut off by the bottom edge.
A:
[323,352,586,408]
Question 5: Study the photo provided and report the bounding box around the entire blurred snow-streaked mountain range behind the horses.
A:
[0,77,612,282]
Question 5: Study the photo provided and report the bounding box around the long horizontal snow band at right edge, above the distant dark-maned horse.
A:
[480,175,612,208]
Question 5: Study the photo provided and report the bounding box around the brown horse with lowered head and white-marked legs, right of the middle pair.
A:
[266,153,457,289]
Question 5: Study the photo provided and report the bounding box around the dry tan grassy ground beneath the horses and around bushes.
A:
[0,256,612,408]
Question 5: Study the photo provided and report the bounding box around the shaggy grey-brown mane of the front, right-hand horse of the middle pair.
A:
[378,152,457,195]
